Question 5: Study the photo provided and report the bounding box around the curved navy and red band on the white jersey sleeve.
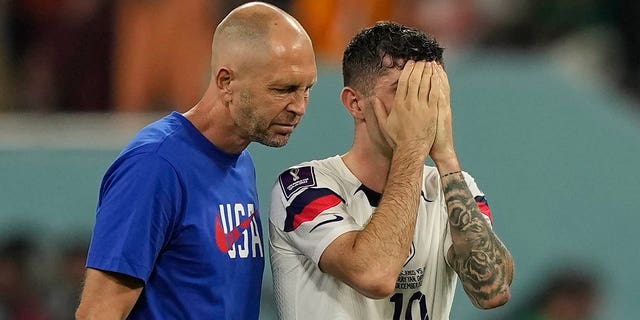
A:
[284,188,344,232]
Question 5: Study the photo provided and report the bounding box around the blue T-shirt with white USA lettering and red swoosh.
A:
[87,112,264,320]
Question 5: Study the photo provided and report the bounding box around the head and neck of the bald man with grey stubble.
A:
[185,2,318,154]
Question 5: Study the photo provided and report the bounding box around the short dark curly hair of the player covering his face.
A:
[342,21,444,95]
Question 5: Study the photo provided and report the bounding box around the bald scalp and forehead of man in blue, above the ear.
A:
[211,2,312,70]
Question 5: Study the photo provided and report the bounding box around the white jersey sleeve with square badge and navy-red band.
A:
[269,166,362,264]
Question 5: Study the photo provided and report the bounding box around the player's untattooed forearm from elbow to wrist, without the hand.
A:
[320,141,426,299]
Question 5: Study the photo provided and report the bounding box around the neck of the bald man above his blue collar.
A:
[184,89,251,154]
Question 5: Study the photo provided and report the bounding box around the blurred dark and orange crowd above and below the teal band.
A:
[0,0,640,320]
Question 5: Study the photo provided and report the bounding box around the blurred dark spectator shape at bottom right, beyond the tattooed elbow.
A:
[502,268,600,320]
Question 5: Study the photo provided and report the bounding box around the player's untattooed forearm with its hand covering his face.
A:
[319,62,437,299]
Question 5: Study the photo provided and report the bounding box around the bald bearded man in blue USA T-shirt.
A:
[76,2,317,319]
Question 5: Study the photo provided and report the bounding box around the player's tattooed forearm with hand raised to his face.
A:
[430,66,513,309]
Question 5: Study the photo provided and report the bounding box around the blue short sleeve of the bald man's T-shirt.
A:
[87,154,182,282]
